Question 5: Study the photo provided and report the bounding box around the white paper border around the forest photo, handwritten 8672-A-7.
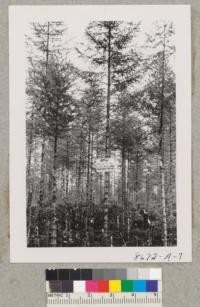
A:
[9,5,192,263]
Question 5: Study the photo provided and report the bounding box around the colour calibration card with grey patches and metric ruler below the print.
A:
[46,268,162,307]
